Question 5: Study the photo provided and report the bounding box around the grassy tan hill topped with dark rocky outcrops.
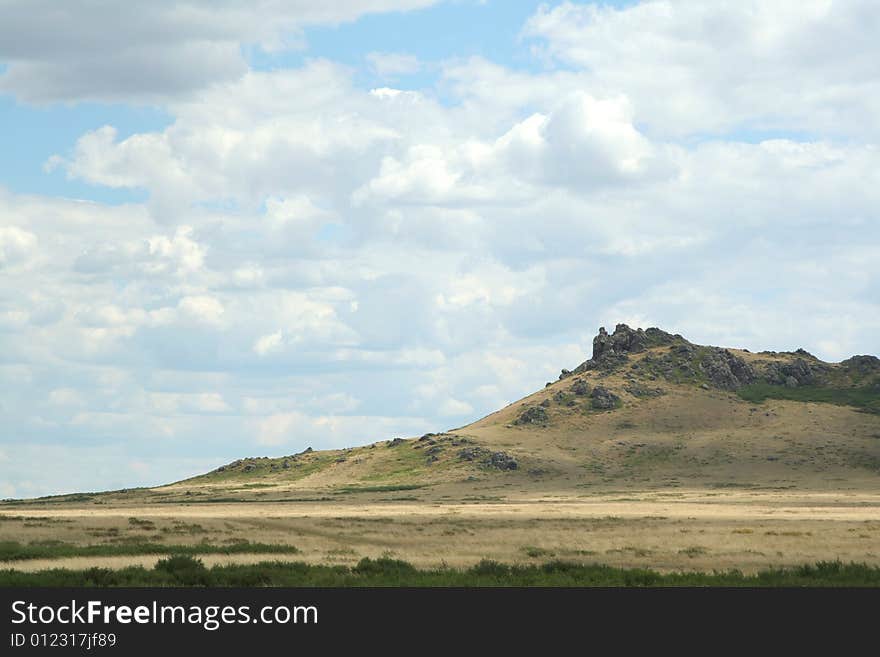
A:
[62,324,880,502]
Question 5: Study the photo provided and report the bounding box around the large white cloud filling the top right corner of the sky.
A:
[524,0,880,137]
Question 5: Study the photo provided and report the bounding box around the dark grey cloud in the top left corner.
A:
[0,0,437,103]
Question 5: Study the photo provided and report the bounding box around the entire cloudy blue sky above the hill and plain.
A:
[0,0,880,498]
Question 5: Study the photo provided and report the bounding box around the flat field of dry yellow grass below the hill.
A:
[0,490,880,572]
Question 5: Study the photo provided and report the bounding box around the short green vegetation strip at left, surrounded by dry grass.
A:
[0,541,299,561]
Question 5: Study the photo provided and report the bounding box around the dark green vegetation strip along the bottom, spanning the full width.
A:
[0,555,880,587]
